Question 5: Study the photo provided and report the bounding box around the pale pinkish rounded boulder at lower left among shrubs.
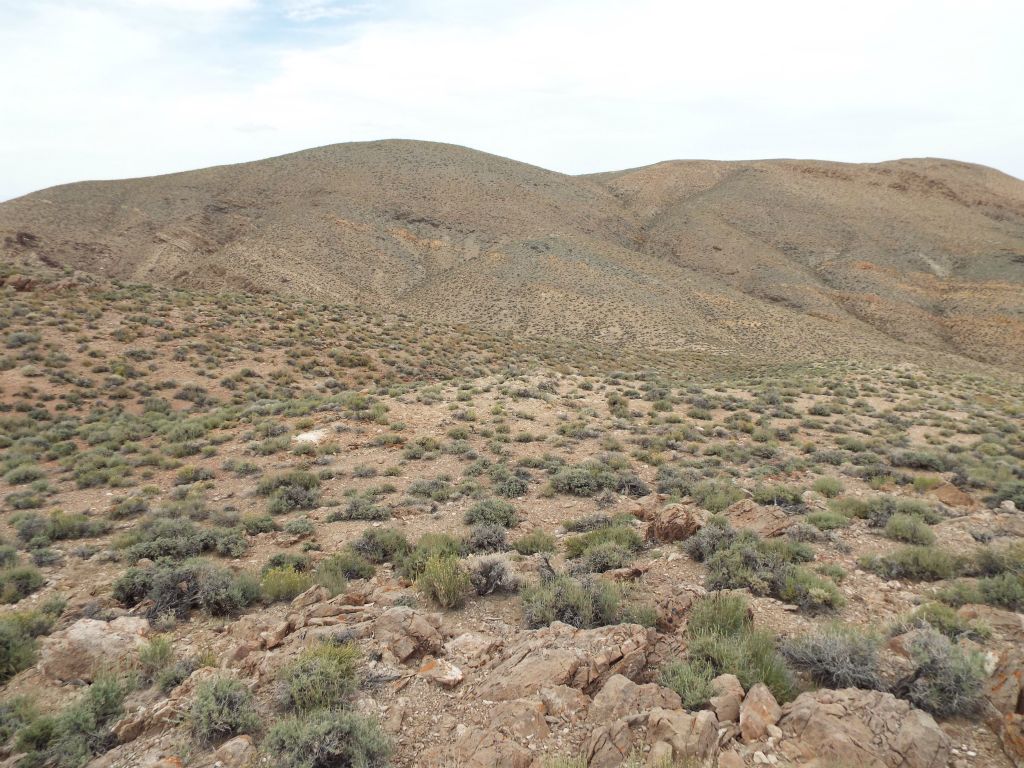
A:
[39,616,150,682]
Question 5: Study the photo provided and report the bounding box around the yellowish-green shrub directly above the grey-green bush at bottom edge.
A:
[278,642,359,712]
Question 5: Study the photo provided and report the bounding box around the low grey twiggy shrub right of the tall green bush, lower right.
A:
[781,625,886,690]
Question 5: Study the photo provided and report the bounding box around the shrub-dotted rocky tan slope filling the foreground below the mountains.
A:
[0,281,1024,768]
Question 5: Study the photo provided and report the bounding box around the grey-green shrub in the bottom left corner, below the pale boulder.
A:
[15,676,131,768]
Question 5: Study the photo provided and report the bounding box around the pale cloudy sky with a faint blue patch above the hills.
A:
[0,0,1024,200]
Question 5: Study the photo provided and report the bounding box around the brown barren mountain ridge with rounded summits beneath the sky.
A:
[0,140,1024,369]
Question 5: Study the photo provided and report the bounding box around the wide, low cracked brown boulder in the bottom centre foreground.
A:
[478,622,655,701]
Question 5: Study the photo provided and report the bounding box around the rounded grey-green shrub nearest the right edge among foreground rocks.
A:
[893,630,985,717]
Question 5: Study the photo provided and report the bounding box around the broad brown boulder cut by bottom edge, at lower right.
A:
[778,688,950,768]
